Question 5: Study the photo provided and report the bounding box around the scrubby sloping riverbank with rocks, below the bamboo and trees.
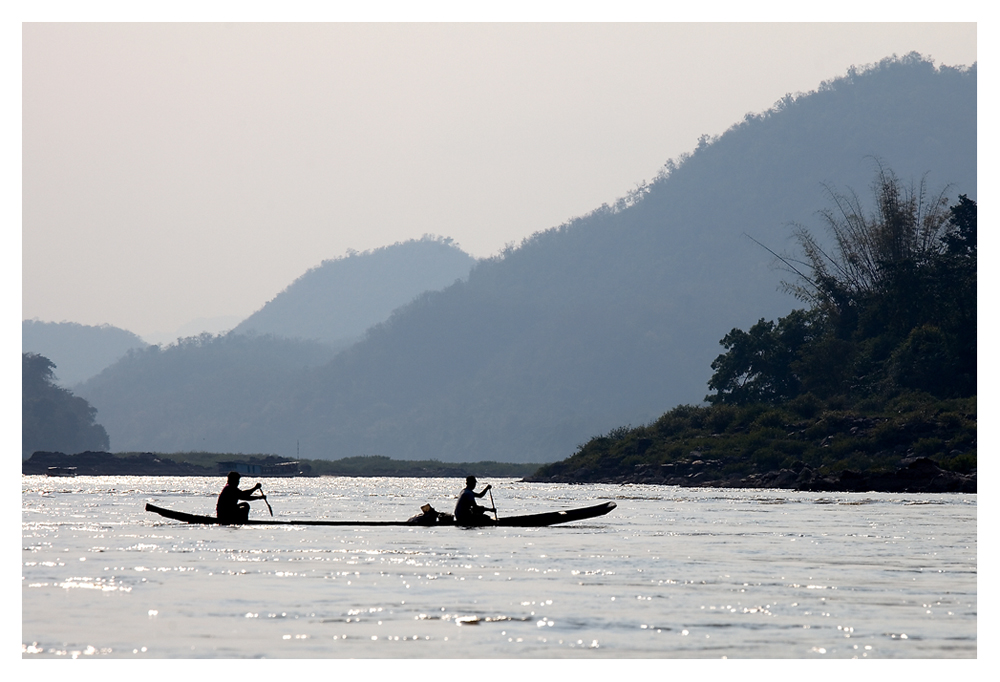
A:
[526,394,977,493]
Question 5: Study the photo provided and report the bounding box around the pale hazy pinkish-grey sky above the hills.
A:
[22,23,977,338]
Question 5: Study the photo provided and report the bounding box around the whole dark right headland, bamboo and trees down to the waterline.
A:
[532,170,977,492]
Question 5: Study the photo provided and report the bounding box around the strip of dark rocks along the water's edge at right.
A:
[523,457,976,493]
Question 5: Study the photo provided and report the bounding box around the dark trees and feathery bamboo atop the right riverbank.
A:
[706,168,976,404]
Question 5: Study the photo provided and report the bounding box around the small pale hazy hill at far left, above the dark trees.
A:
[21,320,147,387]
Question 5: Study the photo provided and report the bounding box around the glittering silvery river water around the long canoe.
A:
[21,476,977,659]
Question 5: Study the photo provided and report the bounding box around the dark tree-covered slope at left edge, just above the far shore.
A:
[21,353,110,459]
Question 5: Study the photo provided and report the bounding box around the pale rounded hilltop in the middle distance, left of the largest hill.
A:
[233,236,476,346]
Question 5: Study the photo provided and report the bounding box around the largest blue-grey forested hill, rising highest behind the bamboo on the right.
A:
[78,56,976,462]
